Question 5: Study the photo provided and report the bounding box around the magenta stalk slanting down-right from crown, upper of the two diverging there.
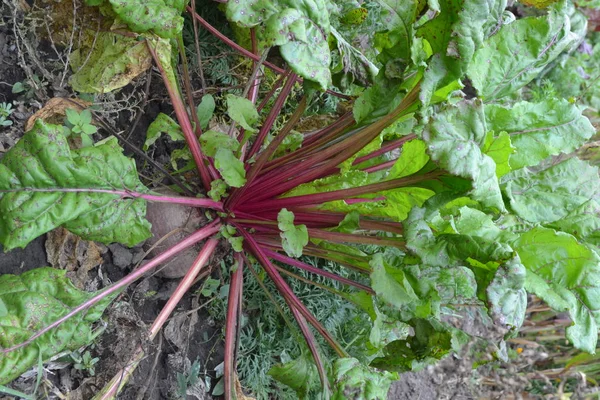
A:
[236,226,348,357]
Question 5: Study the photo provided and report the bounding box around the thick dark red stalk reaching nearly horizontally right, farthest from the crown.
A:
[240,170,444,213]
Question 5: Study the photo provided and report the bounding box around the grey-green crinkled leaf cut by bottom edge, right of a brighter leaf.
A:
[331,358,398,400]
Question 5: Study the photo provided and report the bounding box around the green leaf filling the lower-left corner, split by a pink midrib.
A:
[0,268,114,384]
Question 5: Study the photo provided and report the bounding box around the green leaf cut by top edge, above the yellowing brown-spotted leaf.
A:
[109,0,187,39]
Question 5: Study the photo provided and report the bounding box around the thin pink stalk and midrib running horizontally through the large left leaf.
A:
[0,188,223,211]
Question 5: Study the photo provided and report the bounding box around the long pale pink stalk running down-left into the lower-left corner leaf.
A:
[0,220,221,353]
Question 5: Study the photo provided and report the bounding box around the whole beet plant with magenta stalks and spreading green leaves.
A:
[0,0,600,399]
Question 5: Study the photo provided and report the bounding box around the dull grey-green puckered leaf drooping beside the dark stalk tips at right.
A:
[423,101,505,211]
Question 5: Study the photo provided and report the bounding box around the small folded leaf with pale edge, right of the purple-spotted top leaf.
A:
[331,27,379,86]
